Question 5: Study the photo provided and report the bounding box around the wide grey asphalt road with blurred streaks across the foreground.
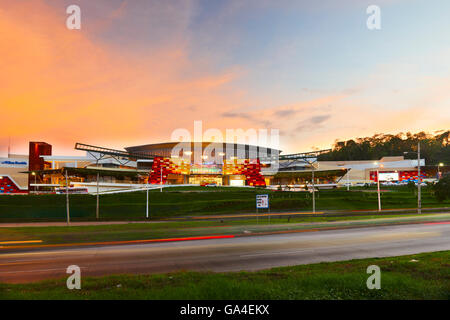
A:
[0,222,450,283]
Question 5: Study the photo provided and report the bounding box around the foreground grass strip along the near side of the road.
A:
[0,251,450,300]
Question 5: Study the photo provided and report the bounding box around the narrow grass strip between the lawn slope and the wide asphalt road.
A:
[0,214,449,248]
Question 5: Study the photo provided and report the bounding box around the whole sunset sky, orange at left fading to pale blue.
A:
[0,0,450,156]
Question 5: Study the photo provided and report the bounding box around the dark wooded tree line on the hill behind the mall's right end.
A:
[318,130,450,165]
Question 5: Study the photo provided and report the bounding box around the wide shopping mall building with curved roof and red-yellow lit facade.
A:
[0,142,442,194]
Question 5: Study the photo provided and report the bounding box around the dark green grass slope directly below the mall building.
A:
[0,187,450,222]
